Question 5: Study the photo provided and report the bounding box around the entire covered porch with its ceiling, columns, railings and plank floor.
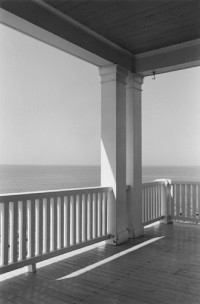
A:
[0,0,200,304]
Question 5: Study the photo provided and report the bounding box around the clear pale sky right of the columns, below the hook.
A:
[142,67,200,166]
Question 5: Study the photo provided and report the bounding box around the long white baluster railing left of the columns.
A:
[0,187,112,274]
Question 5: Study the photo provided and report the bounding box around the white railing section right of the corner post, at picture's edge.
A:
[170,181,200,222]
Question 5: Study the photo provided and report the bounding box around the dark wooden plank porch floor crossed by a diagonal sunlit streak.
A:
[0,224,200,304]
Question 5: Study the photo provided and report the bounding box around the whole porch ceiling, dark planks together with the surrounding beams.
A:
[0,0,200,76]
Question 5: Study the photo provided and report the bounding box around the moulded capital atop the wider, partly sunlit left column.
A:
[99,64,128,84]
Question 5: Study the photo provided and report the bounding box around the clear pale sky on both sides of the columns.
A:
[0,25,200,166]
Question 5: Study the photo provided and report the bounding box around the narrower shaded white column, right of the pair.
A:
[126,73,144,238]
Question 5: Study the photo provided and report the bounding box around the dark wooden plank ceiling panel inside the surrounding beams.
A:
[44,0,200,54]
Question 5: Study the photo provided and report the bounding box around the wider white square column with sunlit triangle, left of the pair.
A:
[100,65,128,244]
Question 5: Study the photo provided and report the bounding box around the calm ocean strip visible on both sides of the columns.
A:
[0,165,200,194]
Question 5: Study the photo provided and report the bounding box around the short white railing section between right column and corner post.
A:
[142,182,167,225]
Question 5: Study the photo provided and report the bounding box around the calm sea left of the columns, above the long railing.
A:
[0,165,100,194]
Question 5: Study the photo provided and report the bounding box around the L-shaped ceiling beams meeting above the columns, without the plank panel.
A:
[0,0,200,76]
